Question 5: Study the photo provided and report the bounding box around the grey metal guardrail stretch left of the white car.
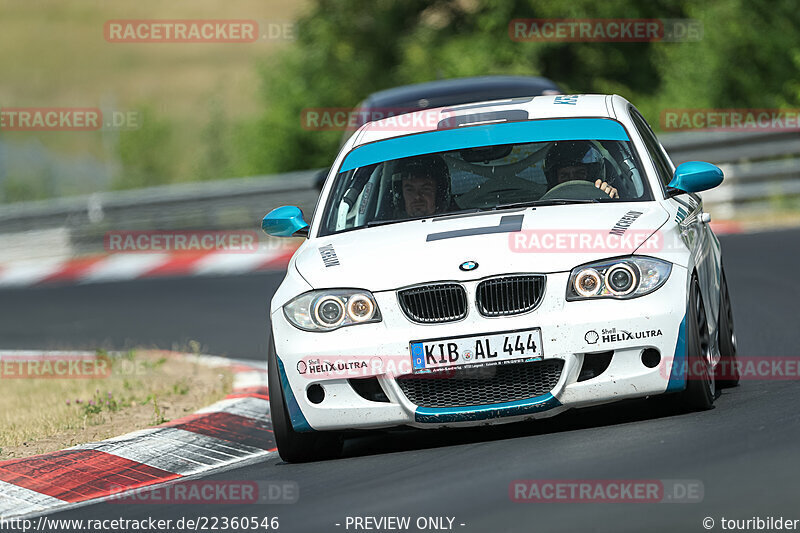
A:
[0,166,319,263]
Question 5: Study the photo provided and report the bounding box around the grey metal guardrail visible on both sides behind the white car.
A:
[0,132,800,262]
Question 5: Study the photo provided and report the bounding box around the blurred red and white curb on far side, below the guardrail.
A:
[0,242,297,287]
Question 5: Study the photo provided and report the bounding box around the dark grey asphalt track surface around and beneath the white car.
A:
[0,230,800,533]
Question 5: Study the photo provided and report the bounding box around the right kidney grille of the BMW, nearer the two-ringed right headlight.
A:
[475,275,545,316]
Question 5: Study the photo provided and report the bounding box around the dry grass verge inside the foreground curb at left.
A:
[0,350,233,460]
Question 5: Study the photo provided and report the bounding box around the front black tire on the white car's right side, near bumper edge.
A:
[679,276,716,411]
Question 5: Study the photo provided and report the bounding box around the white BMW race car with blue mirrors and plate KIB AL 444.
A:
[262,95,738,461]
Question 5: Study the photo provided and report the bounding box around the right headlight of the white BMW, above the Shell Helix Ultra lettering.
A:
[567,257,672,301]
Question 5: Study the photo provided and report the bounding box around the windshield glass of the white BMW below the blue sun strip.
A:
[320,122,652,235]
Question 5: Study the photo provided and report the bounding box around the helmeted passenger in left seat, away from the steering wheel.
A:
[395,155,450,217]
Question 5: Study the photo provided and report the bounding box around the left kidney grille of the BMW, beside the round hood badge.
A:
[397,283,467,324]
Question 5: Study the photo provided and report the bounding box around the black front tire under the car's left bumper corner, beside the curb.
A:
[267,338,342,463]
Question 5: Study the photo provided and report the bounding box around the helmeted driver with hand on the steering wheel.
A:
[544,141,619,198]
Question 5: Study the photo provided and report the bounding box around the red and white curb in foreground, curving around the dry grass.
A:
[0,351,276,519]
